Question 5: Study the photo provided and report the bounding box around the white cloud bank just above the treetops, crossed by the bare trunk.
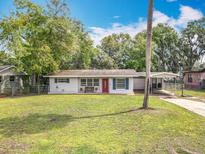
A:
[90,5,203,45]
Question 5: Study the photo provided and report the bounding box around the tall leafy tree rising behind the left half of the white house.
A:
[44,0,93,69]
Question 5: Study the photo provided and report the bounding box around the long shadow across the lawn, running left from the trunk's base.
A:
[0,108,148,137]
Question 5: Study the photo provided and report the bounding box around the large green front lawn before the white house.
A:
[0,95,205,154]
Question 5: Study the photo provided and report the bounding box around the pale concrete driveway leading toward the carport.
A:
[161,98,205,117]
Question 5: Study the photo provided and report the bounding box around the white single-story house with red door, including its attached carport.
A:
[45,69,178,94]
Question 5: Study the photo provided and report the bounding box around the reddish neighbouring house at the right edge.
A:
[184,69,205,89]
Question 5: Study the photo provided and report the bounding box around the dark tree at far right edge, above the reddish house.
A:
[179,18,205,71]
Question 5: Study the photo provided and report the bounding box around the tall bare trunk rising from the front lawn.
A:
[143,0,154,109]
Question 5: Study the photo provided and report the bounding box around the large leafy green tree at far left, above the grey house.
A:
[0,0,57,81]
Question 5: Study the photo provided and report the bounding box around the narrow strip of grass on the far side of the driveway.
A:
[175,90,205,99]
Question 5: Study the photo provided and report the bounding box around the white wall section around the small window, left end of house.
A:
[49,78,78,94]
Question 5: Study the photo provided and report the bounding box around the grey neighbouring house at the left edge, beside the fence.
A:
[0,65,24,94]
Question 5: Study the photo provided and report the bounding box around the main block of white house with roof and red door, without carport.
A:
[45,69,136,94]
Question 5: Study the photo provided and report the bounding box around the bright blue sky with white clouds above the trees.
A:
[0,0,205,44]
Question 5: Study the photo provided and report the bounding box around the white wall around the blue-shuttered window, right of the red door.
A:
[109,77,133,94]
